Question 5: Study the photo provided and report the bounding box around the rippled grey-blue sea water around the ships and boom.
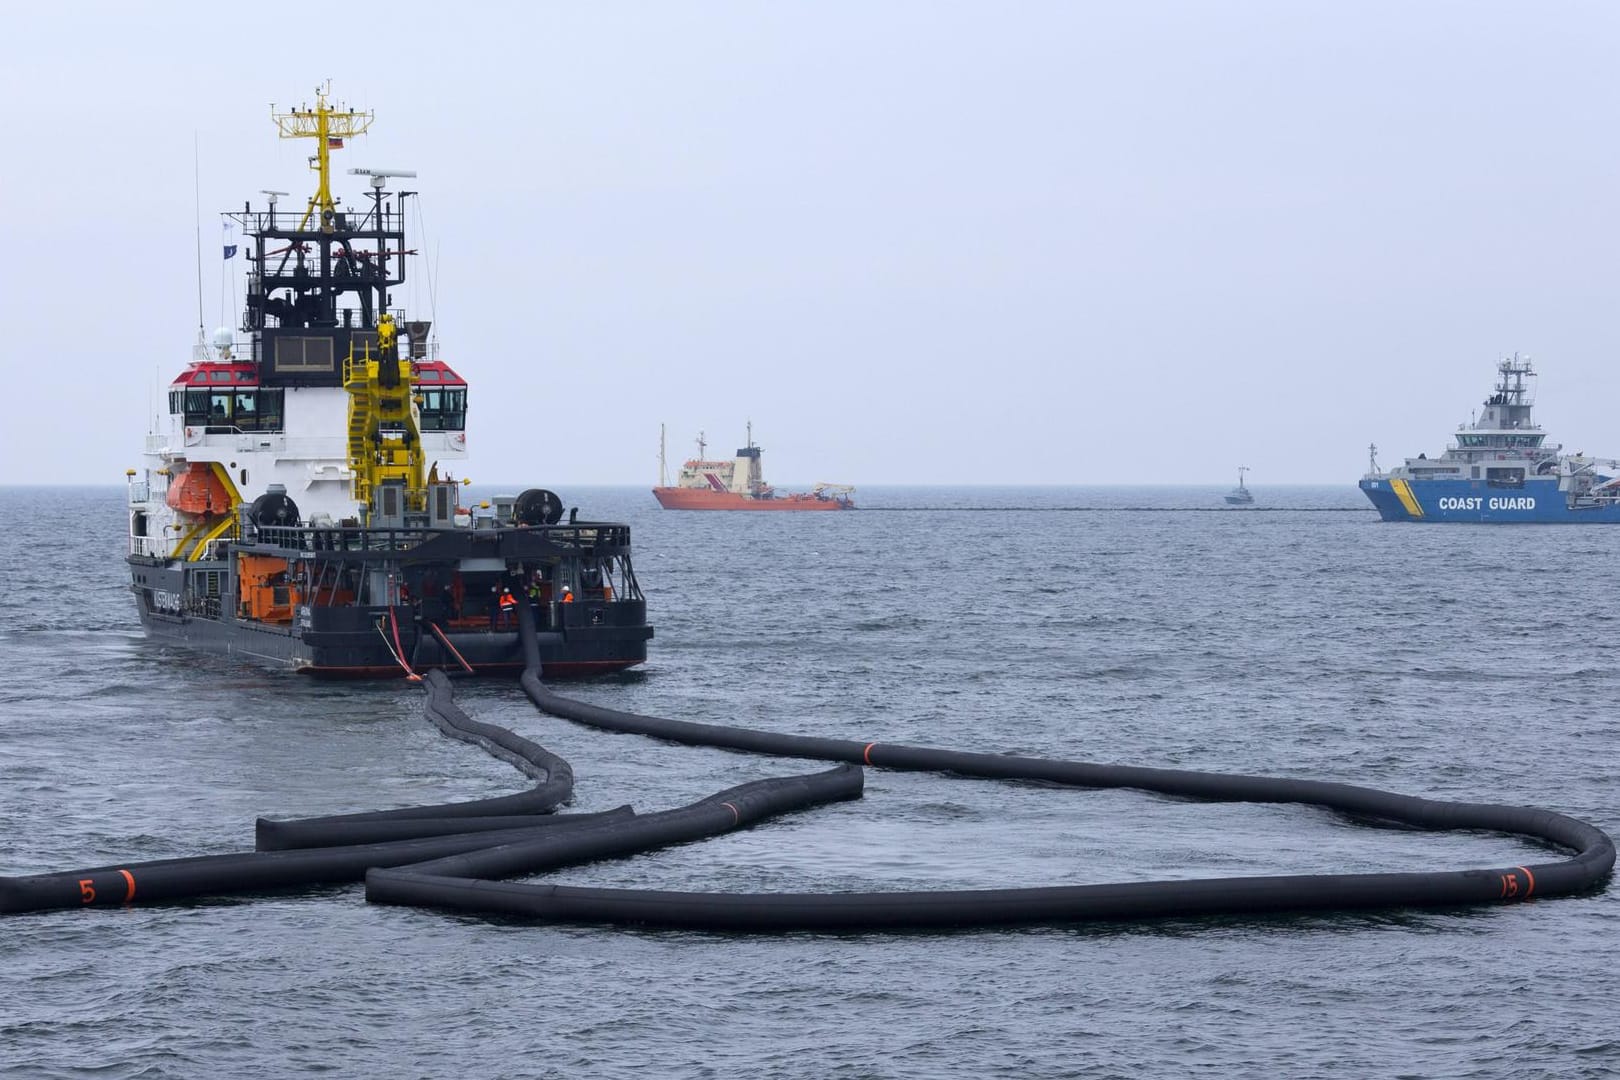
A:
[0,486,1620,1078]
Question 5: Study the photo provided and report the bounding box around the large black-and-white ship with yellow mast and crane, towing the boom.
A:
[128,92,653,677]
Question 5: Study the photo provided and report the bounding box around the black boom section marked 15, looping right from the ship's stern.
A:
[469,599,1615,931]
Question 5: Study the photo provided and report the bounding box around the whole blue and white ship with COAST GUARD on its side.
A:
[1361,355,1620,525]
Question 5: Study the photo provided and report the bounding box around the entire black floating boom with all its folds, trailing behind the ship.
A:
[0,599,1615,933]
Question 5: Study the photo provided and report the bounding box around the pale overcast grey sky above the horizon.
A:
[0,0,1620,486]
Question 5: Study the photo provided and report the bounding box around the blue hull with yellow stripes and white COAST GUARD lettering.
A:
[1361,476,1620,525]
